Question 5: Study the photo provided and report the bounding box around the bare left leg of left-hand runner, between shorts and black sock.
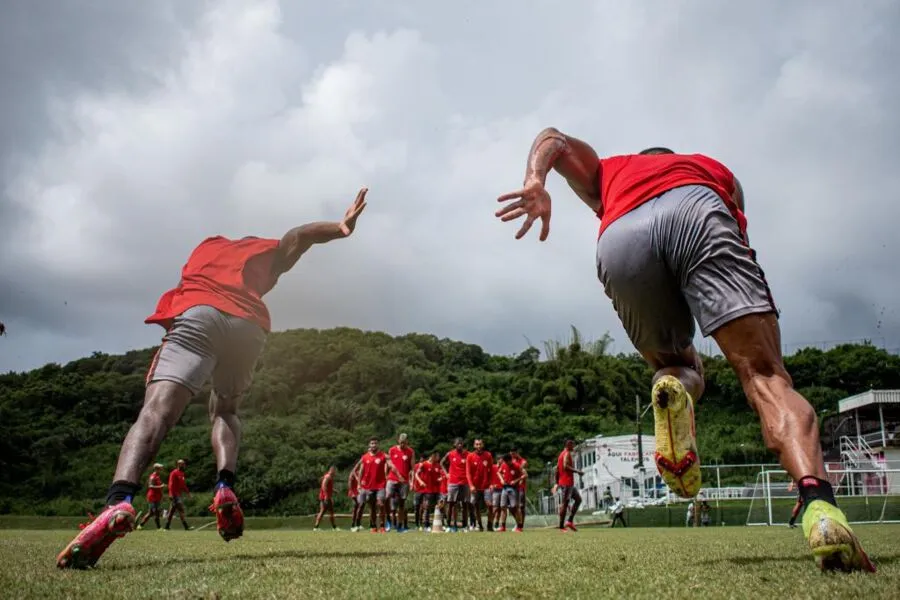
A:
[113,381,193,485]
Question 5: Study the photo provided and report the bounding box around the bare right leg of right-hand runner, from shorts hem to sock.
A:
[713,313,826,481]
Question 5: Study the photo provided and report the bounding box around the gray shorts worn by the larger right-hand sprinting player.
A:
[597,185,778,354]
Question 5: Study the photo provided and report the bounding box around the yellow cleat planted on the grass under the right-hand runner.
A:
[803,500,875,573]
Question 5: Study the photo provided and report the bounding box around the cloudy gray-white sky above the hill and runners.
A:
[0,0,900,371]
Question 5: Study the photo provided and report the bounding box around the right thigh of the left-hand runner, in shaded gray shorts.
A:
[210,315,266,413]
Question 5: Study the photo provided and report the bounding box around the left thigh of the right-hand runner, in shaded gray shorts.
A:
[597,194,694,357]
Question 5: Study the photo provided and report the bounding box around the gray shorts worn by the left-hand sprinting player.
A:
[146,306,266,406]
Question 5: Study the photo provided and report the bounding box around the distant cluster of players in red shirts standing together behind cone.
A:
[314,433,540,533]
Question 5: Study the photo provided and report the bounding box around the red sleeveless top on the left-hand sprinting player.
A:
[144,236,279,332]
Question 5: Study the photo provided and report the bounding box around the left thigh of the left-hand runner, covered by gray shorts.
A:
[146,306,221,394]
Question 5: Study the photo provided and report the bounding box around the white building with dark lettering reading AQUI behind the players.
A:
[574,435,668,510]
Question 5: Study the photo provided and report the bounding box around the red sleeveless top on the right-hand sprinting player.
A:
[600,154,747,235]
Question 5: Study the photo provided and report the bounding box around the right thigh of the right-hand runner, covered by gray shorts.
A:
[664,186,777,336]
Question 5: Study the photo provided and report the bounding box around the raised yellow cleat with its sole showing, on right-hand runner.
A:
[652,375,702,498]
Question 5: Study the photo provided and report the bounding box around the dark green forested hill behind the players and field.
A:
[0,328,900,512]
